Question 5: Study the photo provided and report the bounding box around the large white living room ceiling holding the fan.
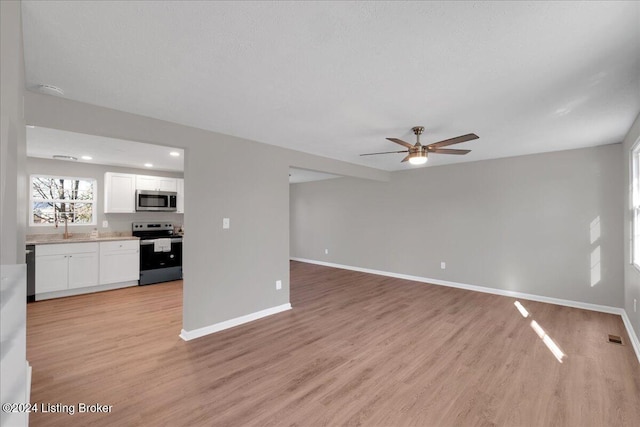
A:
[22,0,640,170]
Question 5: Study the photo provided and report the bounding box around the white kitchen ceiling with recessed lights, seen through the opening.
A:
[27,127,184,172]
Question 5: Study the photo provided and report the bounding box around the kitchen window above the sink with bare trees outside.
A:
[29,175,96,226]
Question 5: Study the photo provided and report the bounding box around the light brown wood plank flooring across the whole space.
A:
[27,262,640,427]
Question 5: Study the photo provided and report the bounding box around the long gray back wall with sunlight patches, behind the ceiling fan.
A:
[290,144,623,307]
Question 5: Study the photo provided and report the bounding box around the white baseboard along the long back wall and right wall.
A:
[290,257,640,363]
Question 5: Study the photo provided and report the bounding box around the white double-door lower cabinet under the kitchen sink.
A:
[36,243,98,294]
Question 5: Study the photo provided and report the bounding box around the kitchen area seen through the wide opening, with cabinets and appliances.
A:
[26,126,184,302]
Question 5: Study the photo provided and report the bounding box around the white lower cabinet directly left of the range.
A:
[100,240,140,285]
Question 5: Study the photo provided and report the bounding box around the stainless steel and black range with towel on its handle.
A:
[132,222,182,285]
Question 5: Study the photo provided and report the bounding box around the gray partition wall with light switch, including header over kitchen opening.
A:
[25,91,389,331]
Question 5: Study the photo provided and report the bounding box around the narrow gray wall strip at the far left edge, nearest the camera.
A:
[0,1,29,426]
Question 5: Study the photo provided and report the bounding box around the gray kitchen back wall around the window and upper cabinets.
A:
[27,157,183,234]
